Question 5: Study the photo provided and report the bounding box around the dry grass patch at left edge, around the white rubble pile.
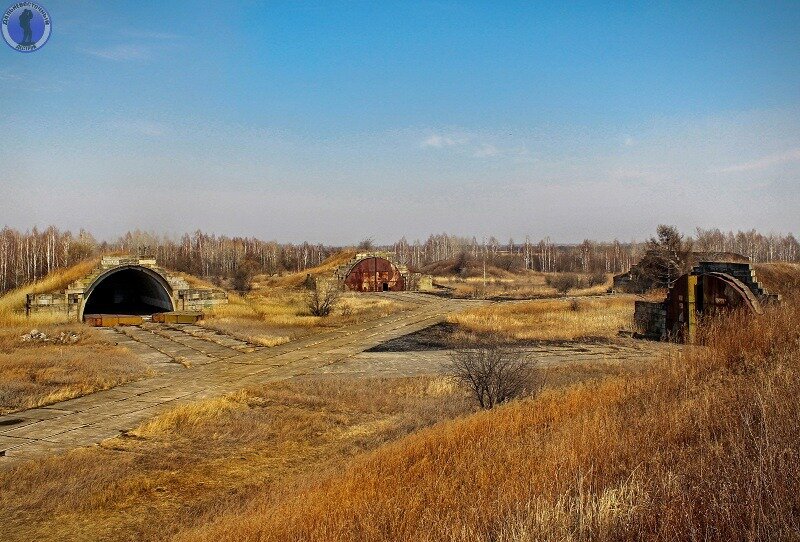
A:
[0,324,150,413]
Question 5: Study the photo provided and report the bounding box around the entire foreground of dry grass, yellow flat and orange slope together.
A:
[0,306,800,542]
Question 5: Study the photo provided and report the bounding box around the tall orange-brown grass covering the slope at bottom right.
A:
[177,300,800,542]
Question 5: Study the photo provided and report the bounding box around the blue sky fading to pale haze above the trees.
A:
[0,0,800,244]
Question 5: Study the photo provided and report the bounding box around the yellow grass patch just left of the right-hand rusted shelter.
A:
[447,296,634,341]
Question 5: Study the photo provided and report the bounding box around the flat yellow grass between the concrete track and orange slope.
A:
[0,378,476,542]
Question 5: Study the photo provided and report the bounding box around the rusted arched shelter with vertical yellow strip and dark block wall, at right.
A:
[634,262,780,342]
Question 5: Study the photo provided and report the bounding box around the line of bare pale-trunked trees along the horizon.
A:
[0,226,800,298]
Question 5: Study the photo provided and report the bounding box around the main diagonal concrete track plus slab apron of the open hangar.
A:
[0,293,476,464]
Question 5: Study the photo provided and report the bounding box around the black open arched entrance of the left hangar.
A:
[83,267,175,315]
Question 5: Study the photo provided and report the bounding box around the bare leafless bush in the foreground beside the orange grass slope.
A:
[447,344,536,409]
